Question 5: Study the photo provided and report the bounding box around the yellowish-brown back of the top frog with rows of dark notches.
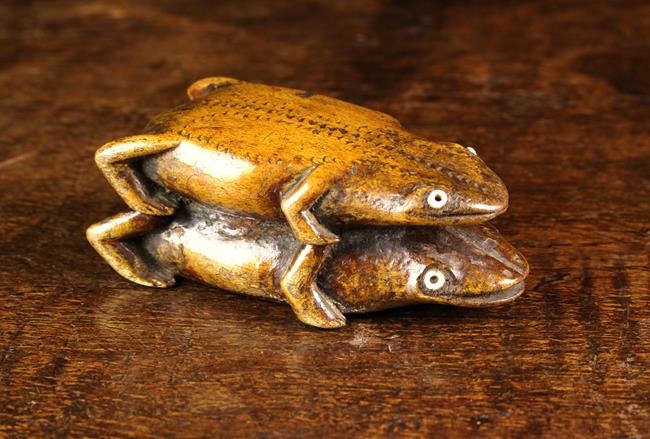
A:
[147,81,407,164]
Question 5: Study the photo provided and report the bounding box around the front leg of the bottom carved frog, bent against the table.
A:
[280,244,345,329]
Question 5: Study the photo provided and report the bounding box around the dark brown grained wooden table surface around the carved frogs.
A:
[0,0,650,438]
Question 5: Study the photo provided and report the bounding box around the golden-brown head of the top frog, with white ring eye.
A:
[321,141,508,225]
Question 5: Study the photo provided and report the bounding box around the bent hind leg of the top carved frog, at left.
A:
[95,134,181,215]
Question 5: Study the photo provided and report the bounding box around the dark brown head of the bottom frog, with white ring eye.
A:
[319,224,528,312]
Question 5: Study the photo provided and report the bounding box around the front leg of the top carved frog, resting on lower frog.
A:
[280,165,339,245]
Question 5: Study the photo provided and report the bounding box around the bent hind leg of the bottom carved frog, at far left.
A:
[86,212,174,288]
